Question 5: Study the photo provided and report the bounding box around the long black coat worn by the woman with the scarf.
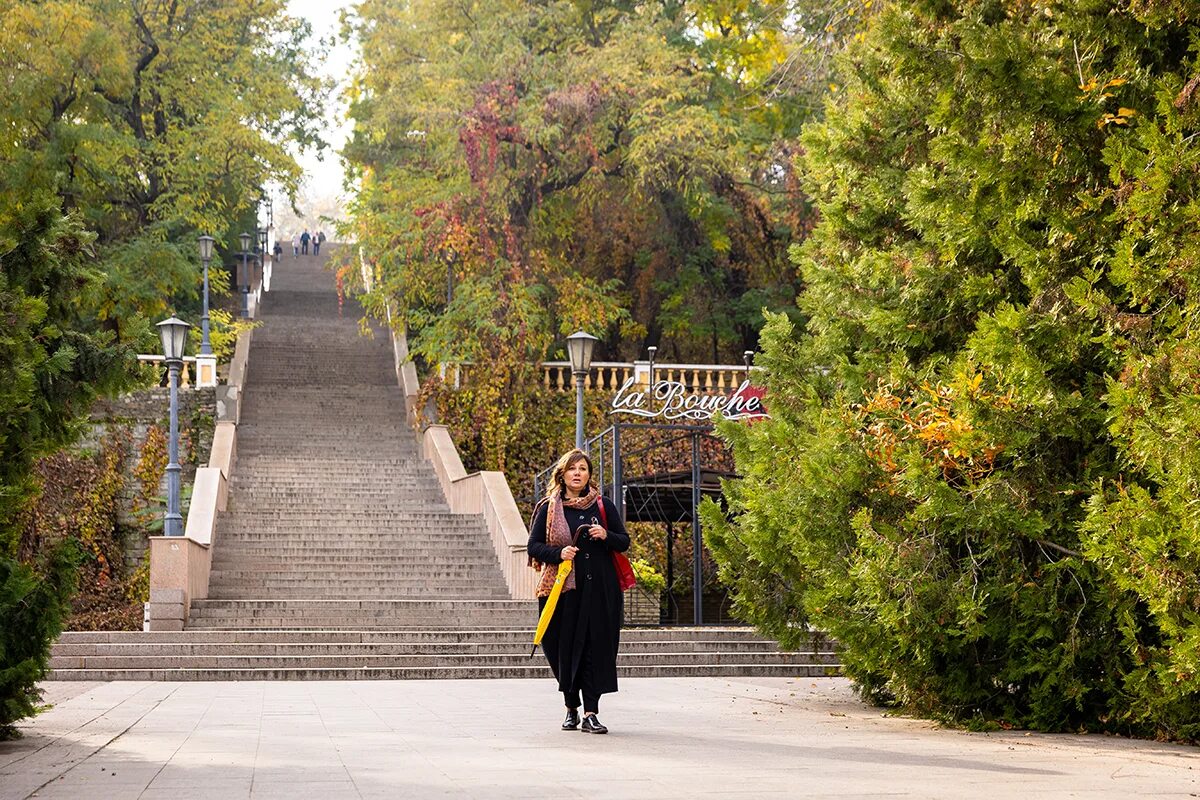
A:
[527,498,629,694]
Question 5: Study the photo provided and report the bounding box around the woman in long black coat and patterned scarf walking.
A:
[526,450,629,733]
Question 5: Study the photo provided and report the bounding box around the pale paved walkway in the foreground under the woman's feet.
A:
[0,678,1200,800]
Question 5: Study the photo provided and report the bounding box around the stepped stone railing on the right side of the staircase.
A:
[389,321,539,600]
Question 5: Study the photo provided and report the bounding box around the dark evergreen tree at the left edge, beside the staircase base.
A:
[0,192,125,738]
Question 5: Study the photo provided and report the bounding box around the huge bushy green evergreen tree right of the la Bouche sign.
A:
[706,0,1200,738]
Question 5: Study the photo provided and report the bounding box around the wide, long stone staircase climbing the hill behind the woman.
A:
[52,247,836,680]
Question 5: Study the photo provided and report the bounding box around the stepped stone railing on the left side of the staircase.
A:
[145,331,253,631]
